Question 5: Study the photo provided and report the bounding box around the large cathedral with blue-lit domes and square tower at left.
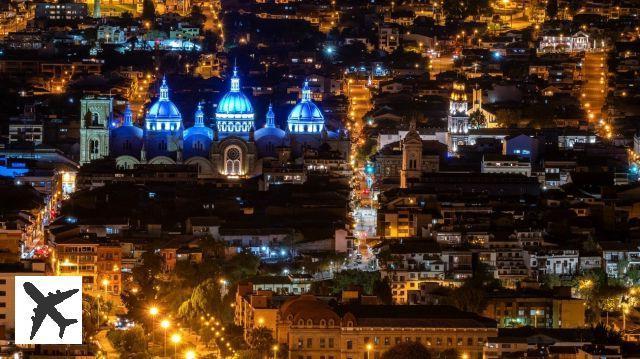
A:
[80,69,350,178]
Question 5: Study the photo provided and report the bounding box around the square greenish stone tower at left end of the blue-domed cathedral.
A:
[80,96,113,165]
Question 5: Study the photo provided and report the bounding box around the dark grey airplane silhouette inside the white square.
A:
[23,282,79,340]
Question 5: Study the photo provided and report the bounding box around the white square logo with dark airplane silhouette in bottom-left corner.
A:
[15,276,82,344]
